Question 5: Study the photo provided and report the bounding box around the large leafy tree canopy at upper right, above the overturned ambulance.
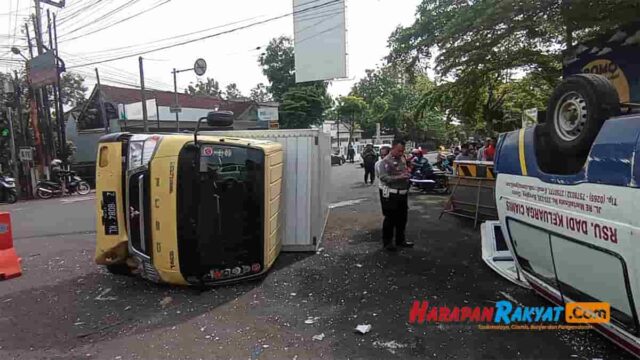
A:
[388,0,640,135]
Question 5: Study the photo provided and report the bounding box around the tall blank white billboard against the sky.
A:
[293,0,347,83]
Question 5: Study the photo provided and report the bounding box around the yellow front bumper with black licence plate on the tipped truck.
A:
[95,133,129,265]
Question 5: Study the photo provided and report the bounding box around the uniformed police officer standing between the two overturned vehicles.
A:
[380,140,413,251]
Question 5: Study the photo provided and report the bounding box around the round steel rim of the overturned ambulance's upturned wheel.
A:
[553,92,588,141]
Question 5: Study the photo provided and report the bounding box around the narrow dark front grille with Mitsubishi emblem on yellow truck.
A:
[127,171,151,258]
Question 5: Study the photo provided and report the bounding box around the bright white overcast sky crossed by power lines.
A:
[0,0,420,96]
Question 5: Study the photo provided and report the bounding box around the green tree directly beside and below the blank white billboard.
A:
[260,37,331,129]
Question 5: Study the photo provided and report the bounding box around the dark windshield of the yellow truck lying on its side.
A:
[177,144,264,277]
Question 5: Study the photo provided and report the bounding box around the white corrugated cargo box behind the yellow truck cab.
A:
[201,130,331,251]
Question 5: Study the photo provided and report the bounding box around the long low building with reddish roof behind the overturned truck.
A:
[65,85,279,184]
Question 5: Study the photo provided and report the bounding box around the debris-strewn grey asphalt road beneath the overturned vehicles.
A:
[0,164,628,359]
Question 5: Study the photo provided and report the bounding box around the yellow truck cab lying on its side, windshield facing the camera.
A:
[95,112,283,286]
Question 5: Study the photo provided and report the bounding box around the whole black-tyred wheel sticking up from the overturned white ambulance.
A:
[546,74,620,156]
